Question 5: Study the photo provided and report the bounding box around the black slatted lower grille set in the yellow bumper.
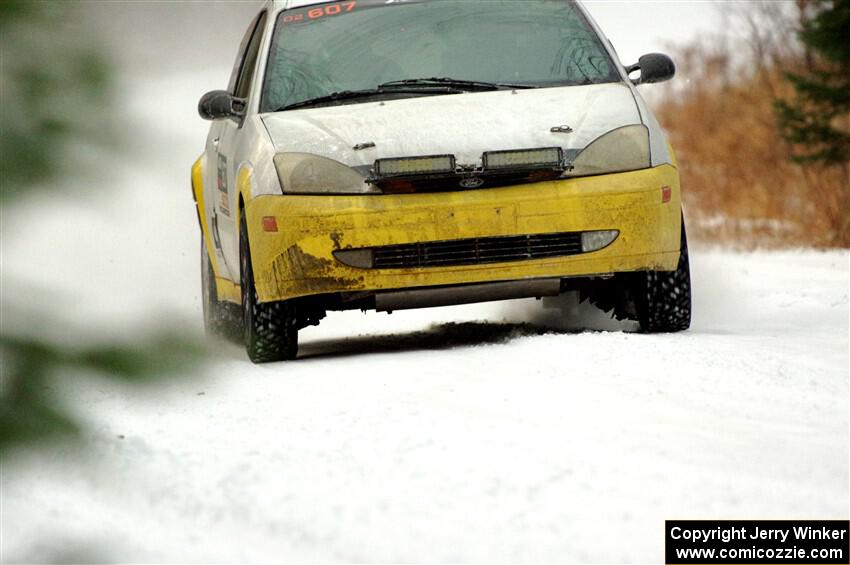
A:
[372,232,582,269]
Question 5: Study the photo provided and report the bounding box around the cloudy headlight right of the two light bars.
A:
[567,125,651,176]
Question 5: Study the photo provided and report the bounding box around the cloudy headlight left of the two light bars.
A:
[274,153,380,194]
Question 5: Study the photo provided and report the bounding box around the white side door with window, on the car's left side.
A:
[206,11,266,282]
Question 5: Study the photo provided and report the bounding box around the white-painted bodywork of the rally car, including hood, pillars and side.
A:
[199,0,671,281]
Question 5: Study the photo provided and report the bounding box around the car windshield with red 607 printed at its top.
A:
[261,0,619,112]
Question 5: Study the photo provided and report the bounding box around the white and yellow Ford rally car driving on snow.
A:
[192,0,691,362]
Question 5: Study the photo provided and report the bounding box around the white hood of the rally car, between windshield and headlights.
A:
[262,83,641,167]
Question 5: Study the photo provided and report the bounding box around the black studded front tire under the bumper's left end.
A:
[239,210,298,363]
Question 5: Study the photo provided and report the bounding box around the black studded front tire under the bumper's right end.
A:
[634,218,691,333]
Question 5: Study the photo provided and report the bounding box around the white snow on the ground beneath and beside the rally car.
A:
[0,71,850,563]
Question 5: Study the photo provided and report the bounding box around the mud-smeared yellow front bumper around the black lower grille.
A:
[245,165,681,302]
